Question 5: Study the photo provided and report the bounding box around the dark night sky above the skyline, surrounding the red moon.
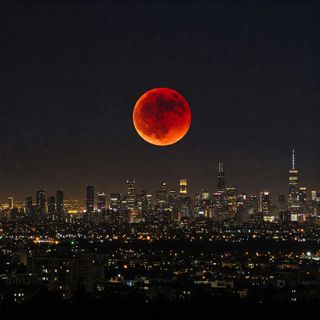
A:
[0,0,320,200]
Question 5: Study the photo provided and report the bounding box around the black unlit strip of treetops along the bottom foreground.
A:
[0,291,320,320]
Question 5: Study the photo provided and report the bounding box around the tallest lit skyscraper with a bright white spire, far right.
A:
[288,150,300,214]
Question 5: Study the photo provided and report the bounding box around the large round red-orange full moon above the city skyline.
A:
[133,88,191,146]
